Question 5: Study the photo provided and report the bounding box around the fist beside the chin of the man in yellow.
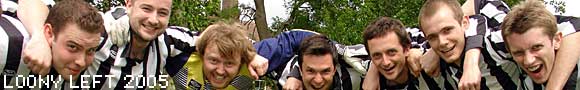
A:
[248,54,268,79]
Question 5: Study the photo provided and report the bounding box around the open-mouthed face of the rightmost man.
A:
[506,28,558,84]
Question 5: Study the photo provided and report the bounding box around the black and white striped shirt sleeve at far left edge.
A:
[0,14,32,88]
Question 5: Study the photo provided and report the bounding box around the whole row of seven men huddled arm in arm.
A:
[0,0,580,90]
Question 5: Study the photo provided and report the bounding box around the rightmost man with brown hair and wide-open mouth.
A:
[501,0,580,90]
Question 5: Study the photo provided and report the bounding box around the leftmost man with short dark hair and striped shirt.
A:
[0,0,105,88]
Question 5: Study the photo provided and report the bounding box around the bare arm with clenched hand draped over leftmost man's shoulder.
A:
[17,0,52,75]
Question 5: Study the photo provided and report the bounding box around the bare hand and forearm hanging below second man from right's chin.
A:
[459,49,481,90]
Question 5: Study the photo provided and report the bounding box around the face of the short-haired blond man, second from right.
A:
[421,6,467,63]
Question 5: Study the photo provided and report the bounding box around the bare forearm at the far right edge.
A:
[546,33,580,90]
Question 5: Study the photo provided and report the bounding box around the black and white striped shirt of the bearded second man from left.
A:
[75,7,197,90]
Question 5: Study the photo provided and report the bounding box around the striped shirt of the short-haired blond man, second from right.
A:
[419,15,521,90]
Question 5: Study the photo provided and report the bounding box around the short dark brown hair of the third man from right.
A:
[363,17,411,52]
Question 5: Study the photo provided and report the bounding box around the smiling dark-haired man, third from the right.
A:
[363,17,419,90]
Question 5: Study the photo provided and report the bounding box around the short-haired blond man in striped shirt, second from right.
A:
[419,0,521,90]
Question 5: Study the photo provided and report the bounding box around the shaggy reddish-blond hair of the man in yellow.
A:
[197,21,256,63]
